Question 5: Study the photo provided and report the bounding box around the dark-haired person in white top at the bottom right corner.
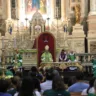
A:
[81,77,96,96]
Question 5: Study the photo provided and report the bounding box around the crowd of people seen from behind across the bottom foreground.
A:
[0,66,96,96]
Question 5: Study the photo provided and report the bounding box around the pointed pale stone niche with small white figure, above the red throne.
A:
[30,11,45,38]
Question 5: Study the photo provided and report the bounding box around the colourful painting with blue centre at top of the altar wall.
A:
[25,0,46,14]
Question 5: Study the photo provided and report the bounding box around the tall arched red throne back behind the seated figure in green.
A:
[37,32,56,65]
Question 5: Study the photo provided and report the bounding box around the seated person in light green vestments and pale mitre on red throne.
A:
[41,45,53,62]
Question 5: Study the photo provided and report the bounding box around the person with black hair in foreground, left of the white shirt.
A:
[14,77,41,96]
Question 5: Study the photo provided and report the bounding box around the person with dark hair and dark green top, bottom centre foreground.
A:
[43,76,70,96]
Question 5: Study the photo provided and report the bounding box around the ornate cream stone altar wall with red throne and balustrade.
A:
[0,0,96,78]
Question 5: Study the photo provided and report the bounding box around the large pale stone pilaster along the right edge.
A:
[87,0,96,53]
